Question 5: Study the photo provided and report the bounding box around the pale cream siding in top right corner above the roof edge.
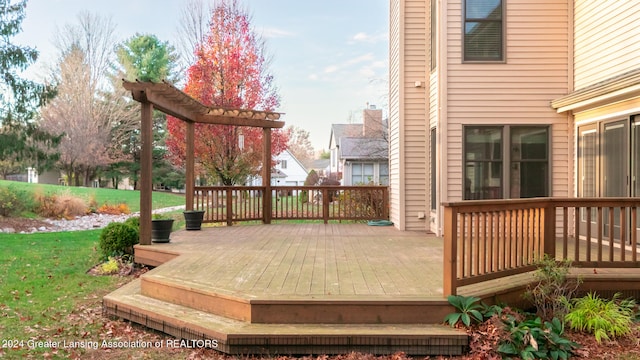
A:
[574,0,640,90]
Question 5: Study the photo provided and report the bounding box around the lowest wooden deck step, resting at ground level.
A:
[103,279,468,355]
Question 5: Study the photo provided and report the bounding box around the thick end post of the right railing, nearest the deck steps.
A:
[442,206,458,297]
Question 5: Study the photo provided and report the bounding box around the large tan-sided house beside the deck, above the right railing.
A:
[389,0,640,234]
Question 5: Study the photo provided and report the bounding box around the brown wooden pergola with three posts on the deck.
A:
[122,80,284,245]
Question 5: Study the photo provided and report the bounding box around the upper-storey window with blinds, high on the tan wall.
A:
[463,0,504,61]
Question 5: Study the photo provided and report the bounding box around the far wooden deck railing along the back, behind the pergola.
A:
[194,186,389,225]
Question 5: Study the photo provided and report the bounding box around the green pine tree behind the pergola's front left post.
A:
[114,34,177,188]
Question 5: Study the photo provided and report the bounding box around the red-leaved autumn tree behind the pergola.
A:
[166,0,287,185]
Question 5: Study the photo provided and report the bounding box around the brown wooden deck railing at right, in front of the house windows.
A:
[443,198,640,296]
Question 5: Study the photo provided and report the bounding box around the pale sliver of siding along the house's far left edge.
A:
[389,0,404,230]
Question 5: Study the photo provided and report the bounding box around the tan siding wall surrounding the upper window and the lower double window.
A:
[440,0,570,201]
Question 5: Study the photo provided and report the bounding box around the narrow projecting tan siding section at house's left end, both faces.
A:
[389,0,430,230]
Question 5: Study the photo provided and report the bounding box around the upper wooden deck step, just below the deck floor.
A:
[140,268,451,324]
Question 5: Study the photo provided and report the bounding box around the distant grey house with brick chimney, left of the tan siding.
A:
[329,106,389,185]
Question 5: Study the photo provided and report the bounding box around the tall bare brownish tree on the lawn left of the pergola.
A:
[42,13,139,186]
